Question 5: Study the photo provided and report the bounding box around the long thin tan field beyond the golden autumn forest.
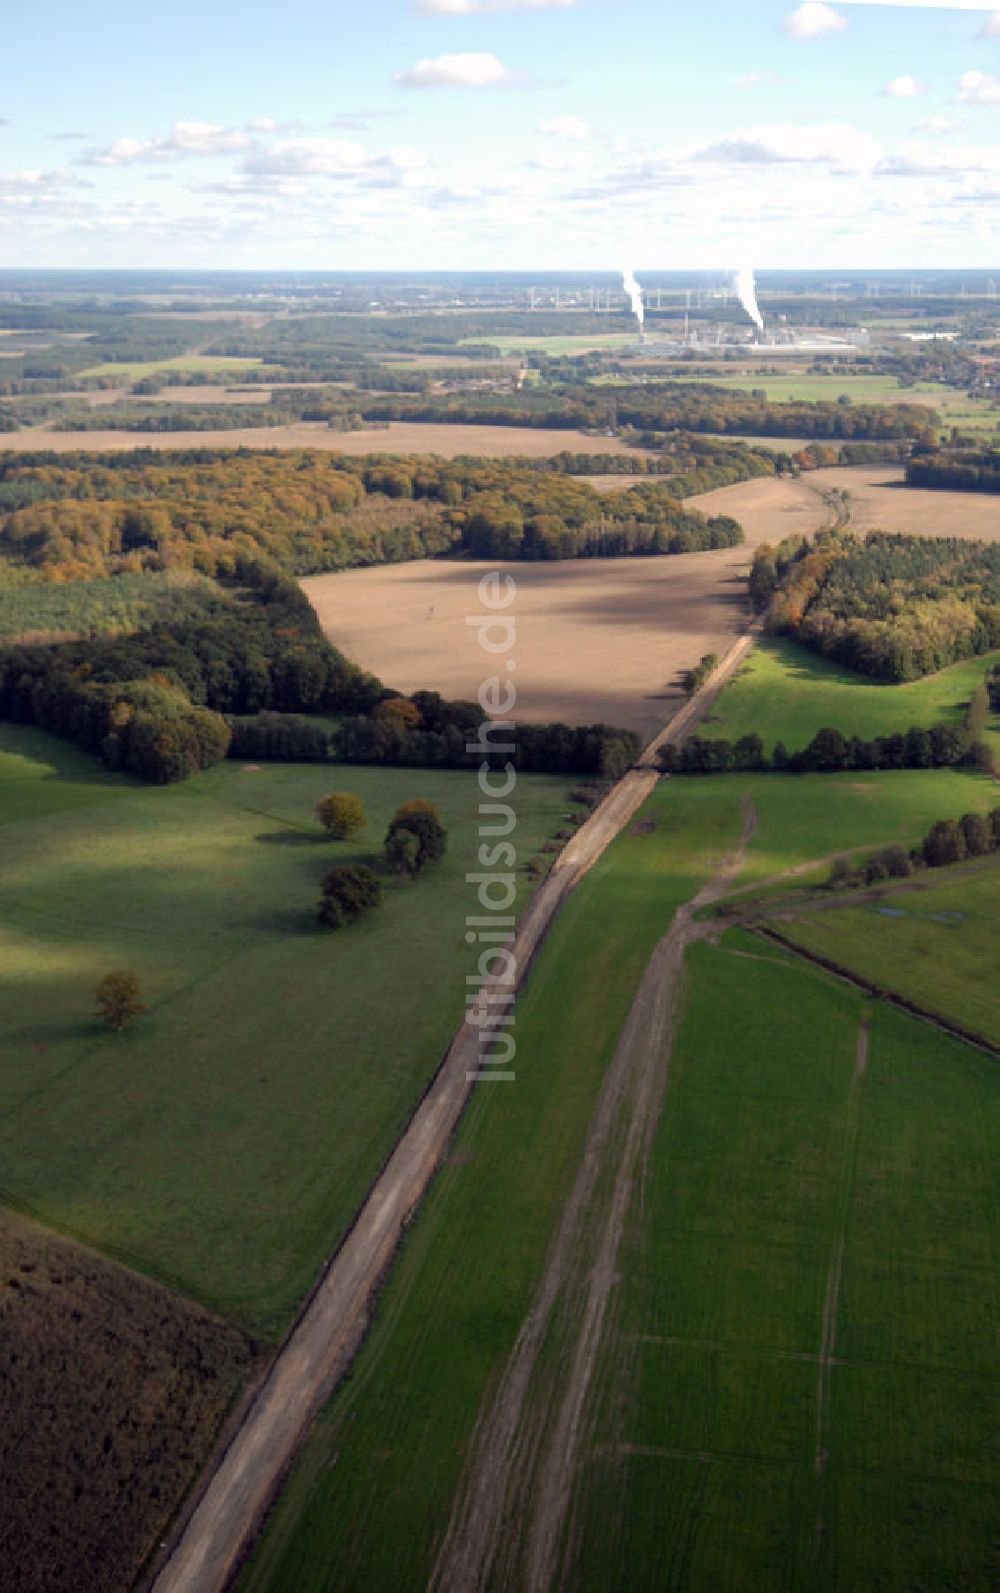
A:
[3,420,642,459]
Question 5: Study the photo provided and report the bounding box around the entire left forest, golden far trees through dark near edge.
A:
[0,451,652,782]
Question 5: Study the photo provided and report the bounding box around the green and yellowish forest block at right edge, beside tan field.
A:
[750,530,1000,682]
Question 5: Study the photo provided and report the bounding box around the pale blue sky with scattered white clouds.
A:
[0,0,1000,274]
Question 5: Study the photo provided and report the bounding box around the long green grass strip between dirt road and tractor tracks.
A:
[240,785,742,1593]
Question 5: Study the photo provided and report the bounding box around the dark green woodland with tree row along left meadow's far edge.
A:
[0,561,639,784]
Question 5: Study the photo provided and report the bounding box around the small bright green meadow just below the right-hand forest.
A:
[701,637,1000,752]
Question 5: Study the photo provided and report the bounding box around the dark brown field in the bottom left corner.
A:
[0,1211,253,1593]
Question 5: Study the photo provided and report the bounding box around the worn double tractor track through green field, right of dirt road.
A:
[432,804,756,1593]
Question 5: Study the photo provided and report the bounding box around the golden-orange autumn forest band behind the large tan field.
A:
[0,449,751,586]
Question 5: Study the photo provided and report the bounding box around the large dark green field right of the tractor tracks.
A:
[566,937,1000,1593]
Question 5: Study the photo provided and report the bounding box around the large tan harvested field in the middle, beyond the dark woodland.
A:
[303,481,830,736]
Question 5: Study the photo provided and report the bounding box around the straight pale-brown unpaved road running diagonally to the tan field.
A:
[151,632,753,1593]
